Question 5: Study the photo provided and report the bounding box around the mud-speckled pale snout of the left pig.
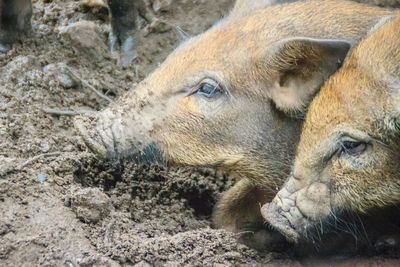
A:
[74,112,165,164]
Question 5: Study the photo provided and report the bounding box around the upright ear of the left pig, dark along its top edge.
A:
[264,38,351,113]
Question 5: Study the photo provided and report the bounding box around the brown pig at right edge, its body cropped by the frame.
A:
[262,16,400,245]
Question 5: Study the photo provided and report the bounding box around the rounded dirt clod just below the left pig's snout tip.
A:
[69,188,112,223]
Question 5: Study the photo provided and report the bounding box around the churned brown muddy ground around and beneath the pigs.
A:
[0,0,396,266]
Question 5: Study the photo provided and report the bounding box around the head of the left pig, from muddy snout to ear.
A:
[75,1,350,186]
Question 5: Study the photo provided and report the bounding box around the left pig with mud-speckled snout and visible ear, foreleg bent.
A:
[74,0,393,249]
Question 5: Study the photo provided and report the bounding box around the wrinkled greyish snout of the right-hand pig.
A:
[261,177,331,243]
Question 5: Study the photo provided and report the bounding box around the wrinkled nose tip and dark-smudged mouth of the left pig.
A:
[74,115,166,165]
